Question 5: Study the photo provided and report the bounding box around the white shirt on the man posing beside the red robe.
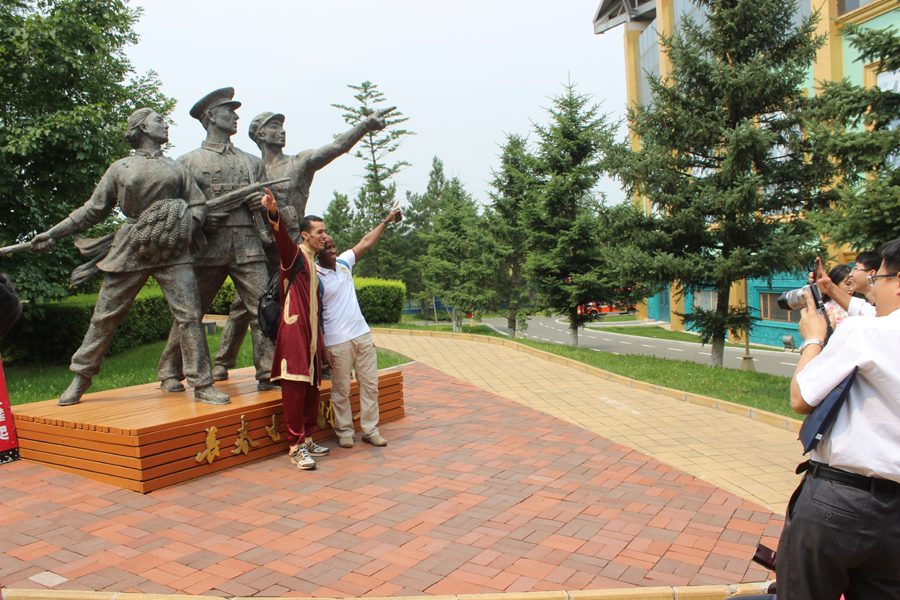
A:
[316,250,371,346]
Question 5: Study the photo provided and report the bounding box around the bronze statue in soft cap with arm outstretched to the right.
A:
[213,106,396,381]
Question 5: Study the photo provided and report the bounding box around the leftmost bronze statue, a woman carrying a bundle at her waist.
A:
[31,108,230,406]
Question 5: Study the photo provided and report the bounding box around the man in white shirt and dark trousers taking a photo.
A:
[778,239,900,600]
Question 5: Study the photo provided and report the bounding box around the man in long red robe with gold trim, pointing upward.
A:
[262,189,331,470]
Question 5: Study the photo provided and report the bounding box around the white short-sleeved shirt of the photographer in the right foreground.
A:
[797,310,900,482]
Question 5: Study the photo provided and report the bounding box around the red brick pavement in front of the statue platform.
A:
[0,364,782,598]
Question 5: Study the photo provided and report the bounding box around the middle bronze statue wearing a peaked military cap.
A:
[157,88,278,392]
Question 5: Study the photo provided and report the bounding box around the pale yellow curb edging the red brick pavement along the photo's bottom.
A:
[0,583,768,600]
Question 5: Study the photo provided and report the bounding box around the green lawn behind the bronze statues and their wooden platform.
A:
[3,330,410,404]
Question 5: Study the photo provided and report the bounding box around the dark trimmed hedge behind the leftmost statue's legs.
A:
[0,286,173,363]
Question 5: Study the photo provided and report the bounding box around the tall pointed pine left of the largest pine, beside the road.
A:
[522,83,613,345]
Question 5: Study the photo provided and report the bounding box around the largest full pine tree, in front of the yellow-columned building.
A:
[610,0,834,366]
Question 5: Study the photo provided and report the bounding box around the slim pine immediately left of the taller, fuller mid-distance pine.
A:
[486,134,535,332]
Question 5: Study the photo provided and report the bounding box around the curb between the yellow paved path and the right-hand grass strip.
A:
[372,327,803,433]
